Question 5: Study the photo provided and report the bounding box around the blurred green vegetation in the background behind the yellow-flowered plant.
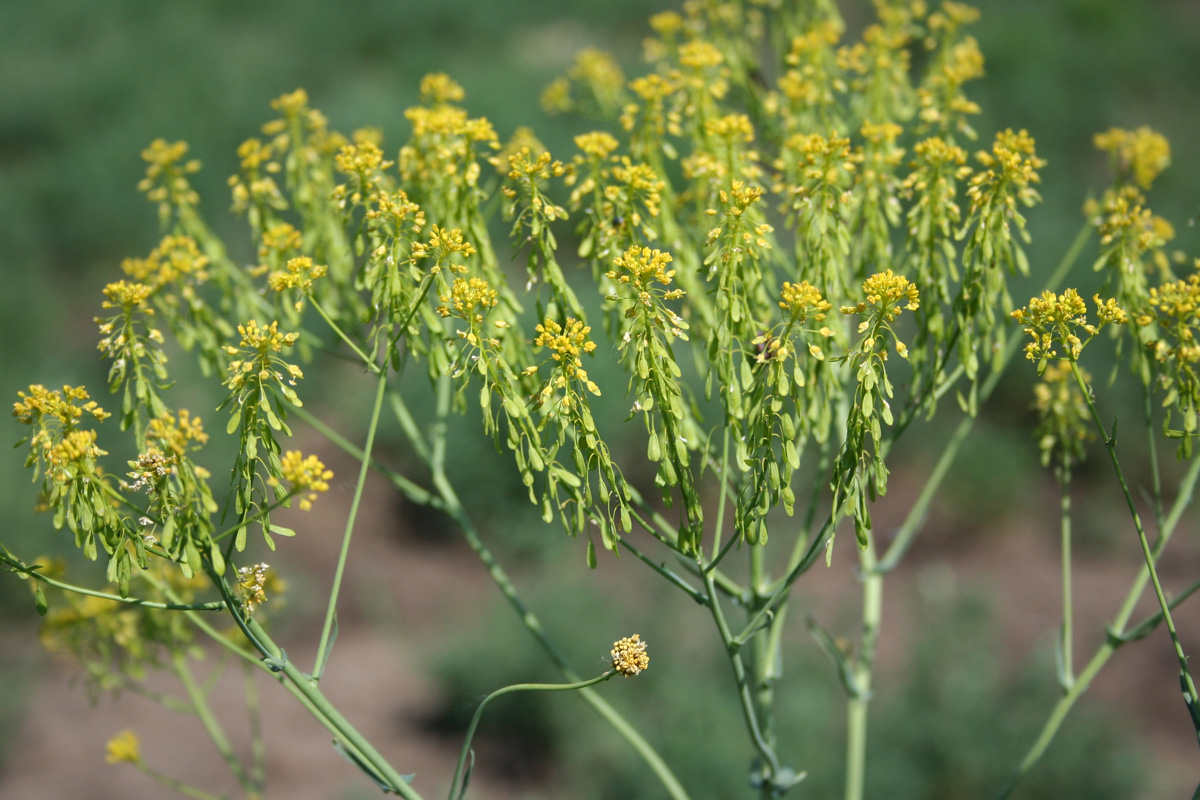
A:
[0,0,1200,798]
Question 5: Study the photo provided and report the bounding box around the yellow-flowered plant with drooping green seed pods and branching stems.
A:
[0,0,1200,800]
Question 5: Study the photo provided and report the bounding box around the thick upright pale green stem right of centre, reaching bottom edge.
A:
[845,534,883,800]
